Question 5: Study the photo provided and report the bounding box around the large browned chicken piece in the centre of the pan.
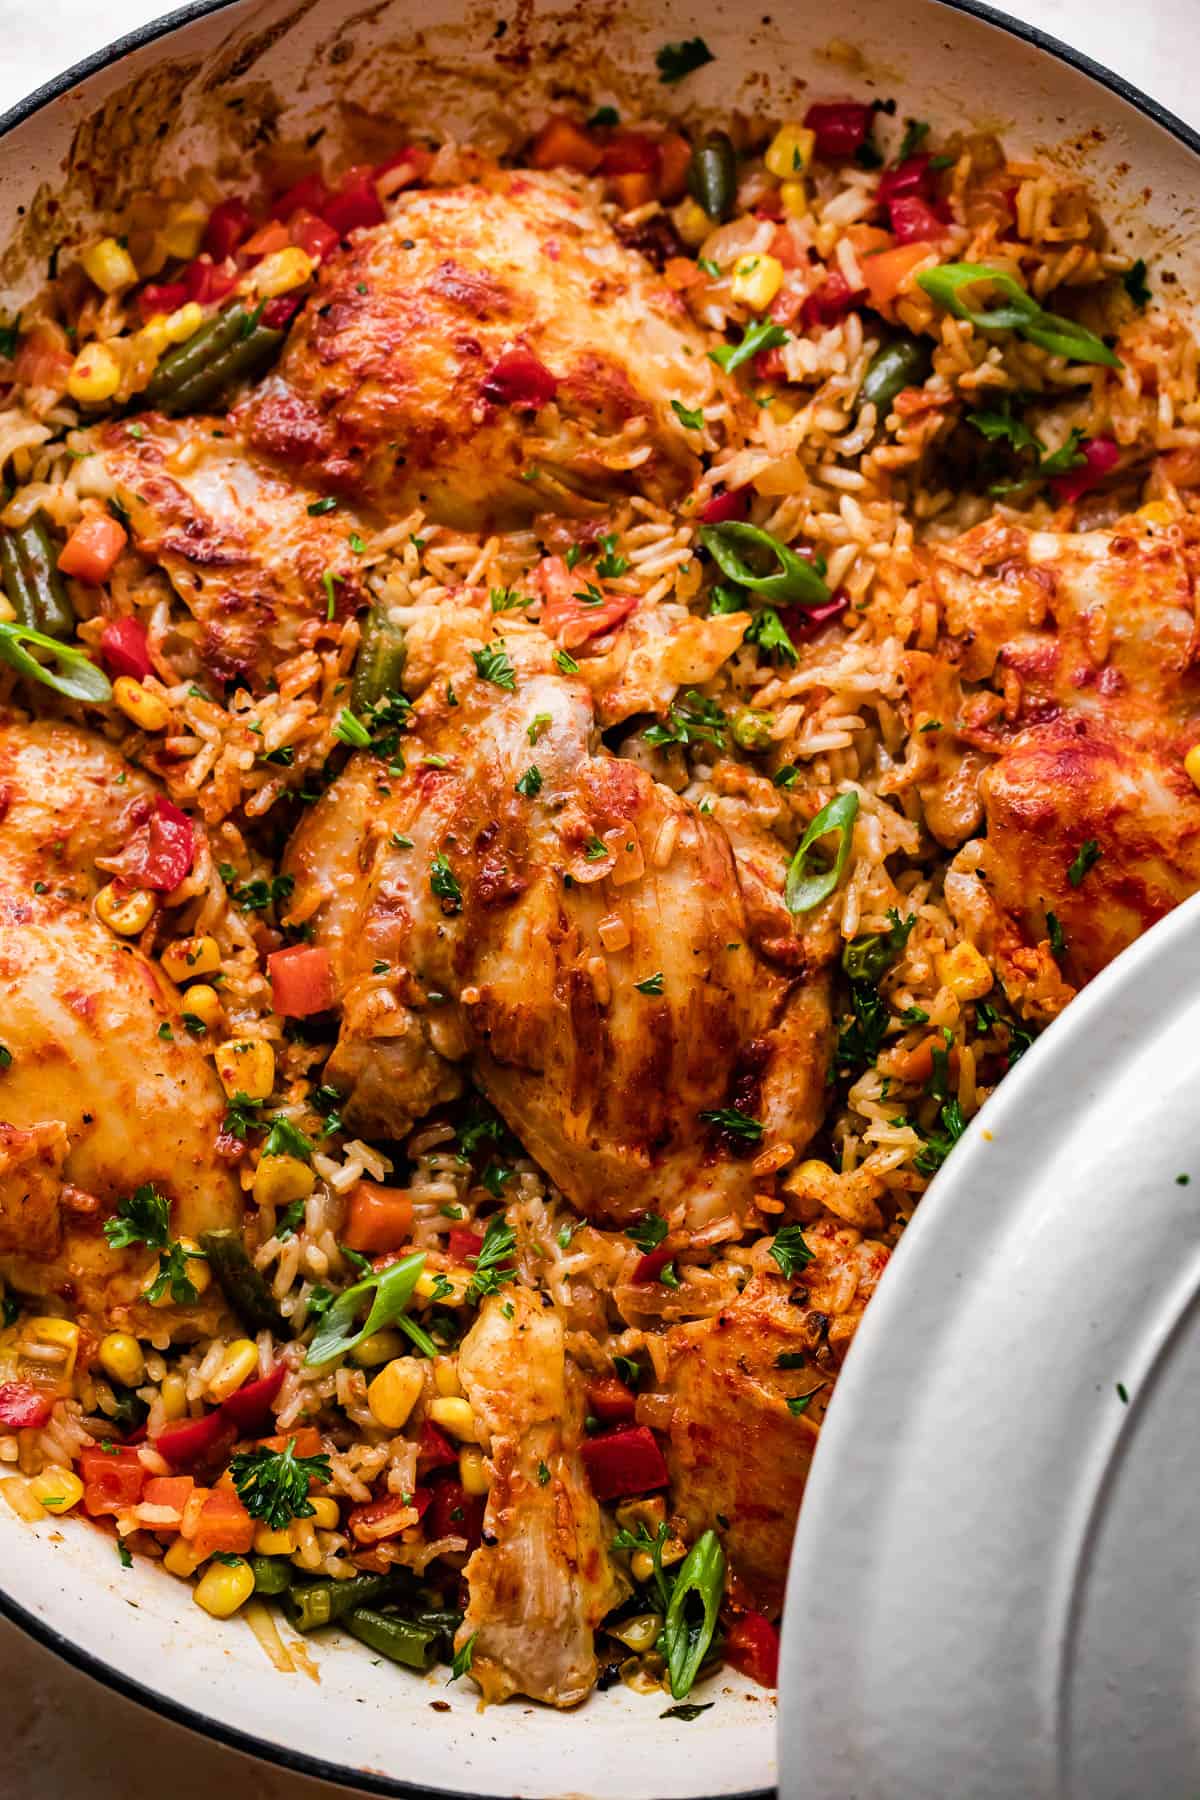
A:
[286,605,829,1224]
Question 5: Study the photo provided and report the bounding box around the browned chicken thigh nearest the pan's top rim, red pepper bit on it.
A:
[245,169,723,527]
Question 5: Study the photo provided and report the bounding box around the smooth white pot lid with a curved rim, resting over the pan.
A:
[779,896,1200,1800]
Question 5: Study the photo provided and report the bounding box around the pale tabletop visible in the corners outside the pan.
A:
[0,0,1200,1800]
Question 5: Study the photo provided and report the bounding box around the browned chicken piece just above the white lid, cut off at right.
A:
[907,522,1200,1012]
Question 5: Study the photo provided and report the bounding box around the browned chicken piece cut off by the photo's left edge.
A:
[0,720,241,1337]
